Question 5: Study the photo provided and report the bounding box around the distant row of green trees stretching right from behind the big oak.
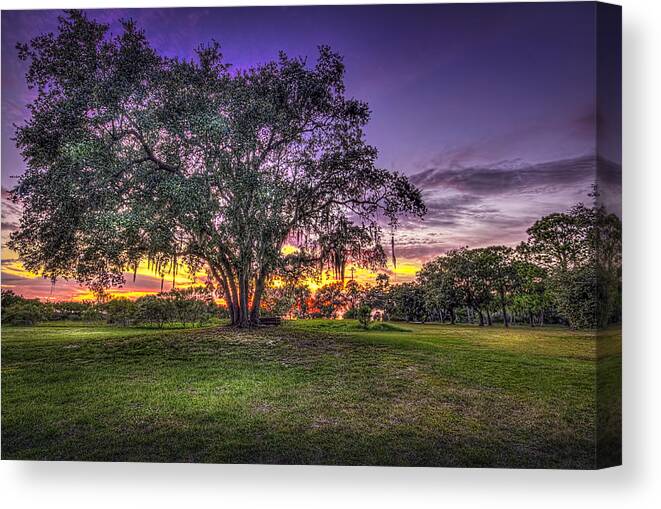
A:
[264,204,622,328]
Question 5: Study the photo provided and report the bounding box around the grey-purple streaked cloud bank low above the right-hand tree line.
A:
[398,156,621,261]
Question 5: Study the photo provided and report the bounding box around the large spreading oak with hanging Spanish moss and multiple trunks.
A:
[10,11,425,325]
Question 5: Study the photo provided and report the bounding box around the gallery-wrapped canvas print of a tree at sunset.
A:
[1,2,622,469]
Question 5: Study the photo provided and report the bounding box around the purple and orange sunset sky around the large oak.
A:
[2,3,621,299]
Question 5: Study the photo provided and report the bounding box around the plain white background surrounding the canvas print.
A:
[0,0,661,509]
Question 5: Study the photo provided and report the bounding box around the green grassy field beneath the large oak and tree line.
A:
[2,320,621,468]
